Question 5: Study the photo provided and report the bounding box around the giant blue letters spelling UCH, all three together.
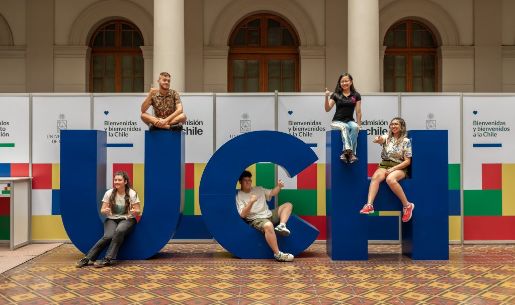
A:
[61,130,448,260]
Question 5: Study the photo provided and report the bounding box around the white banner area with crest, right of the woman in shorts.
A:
[401,95,461,164]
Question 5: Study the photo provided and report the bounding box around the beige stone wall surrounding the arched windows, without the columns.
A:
[0,0,515,92]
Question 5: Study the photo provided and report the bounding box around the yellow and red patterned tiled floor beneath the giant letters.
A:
[0,244,515,304]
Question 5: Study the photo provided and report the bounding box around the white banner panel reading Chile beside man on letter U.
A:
[181,94,214,163]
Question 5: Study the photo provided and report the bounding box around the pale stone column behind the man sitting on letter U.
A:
[153,0,186,91]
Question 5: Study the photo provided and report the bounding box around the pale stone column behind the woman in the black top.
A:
[347,0,381,92]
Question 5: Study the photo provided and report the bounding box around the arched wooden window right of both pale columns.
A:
[383,20,439,92]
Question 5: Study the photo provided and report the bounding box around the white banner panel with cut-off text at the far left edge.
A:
[0,96,30,163]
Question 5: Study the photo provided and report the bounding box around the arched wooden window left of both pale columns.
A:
[89,20,144,92]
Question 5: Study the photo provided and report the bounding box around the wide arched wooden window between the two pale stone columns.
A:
[228,14,300,92]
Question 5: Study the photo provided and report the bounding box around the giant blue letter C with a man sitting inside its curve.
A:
[200,131,319,258]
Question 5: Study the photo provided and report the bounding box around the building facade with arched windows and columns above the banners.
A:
[0,0,515,93]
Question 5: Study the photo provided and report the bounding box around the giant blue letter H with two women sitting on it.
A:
[326,130,449,260]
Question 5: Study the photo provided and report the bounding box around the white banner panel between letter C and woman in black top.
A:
[278,94,334,163]
